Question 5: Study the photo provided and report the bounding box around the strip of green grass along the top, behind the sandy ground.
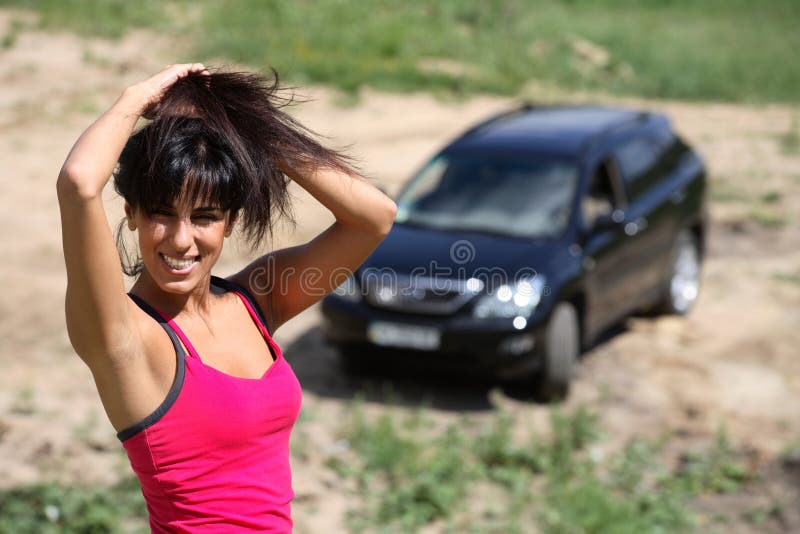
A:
[0,0,800,102]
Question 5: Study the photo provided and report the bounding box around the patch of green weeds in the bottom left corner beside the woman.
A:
[0,477,149,534]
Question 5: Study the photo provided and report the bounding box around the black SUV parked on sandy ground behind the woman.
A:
[322,106,707,399]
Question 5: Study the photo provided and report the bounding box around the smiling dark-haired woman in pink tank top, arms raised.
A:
[57,64,396,532]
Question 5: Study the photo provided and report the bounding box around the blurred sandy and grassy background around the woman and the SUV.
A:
[0,0,800,533]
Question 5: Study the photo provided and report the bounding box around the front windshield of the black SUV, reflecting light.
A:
[396,154,578,238]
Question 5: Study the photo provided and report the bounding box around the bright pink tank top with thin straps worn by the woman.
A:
[117,277,301,532]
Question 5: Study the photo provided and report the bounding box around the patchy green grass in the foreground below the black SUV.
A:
[327,406,761,534]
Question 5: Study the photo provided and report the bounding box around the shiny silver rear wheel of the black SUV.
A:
[659,230,700,315]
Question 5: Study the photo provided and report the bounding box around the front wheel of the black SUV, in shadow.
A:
[536,302,580,402]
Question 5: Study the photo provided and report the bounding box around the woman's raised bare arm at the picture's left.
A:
[57,63,205,367]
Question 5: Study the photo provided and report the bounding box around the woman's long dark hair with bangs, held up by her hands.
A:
[114,71,356,276]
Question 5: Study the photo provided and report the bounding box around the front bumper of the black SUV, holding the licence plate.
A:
[322,298,544,379]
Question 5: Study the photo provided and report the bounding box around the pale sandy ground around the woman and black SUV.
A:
[0,10,800,532]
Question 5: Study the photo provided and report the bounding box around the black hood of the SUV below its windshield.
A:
[360,224,564,285]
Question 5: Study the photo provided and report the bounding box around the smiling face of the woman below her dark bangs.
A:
[125,199,233,293]
